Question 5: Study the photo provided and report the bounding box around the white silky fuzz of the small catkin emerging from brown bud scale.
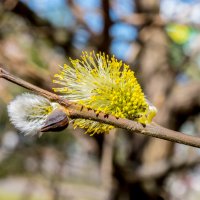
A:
[8,93,54,135]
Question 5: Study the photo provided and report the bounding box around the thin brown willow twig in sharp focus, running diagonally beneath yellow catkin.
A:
[0,68,200,147]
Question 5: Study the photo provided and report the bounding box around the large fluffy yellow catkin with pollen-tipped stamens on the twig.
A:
[53,52,157,134]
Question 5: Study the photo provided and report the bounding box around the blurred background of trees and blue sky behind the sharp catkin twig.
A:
[0,0,200,200]
